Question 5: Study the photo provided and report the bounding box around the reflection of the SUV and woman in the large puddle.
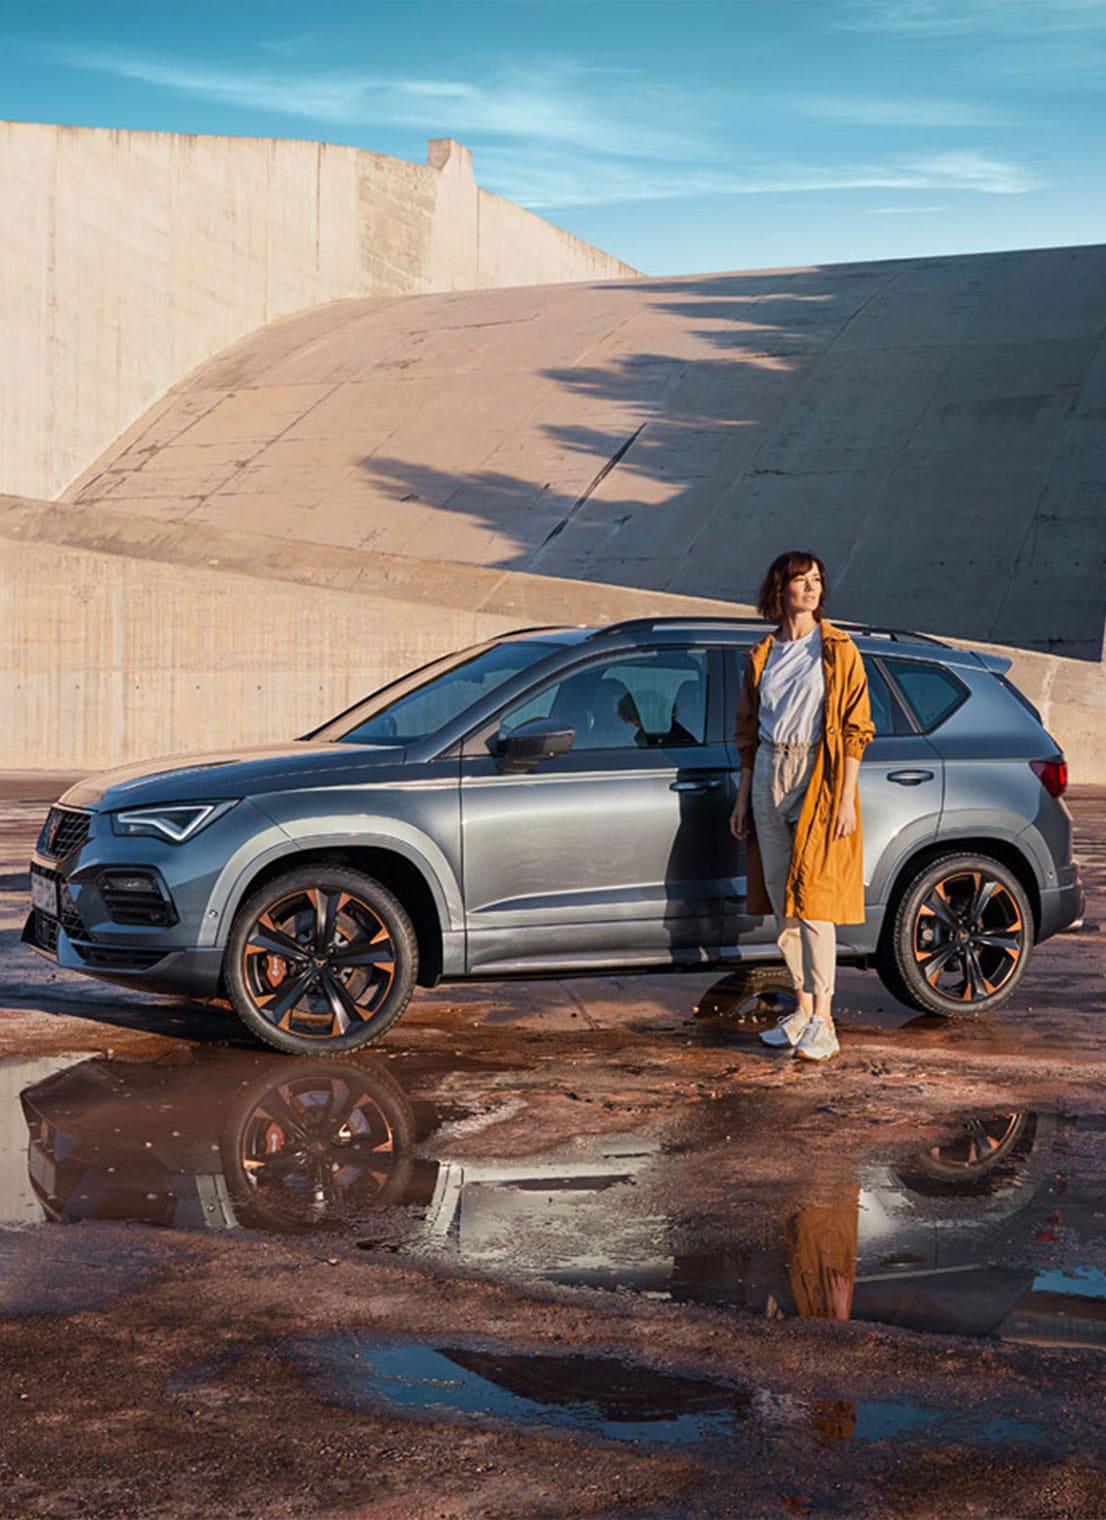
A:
[21,1052,1106,1347]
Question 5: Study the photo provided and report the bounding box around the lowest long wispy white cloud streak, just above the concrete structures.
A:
[479,147,1039,211]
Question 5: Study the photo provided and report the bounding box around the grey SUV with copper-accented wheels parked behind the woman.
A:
[23,619,1083,1053]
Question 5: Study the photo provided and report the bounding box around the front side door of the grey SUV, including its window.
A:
[460,646,732,971]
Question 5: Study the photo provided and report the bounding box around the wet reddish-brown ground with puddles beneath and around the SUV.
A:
[0,783,1106,1520]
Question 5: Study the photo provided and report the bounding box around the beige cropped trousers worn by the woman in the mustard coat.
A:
[752,739,837,997]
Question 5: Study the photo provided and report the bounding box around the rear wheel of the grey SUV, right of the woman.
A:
[877,851,1033,1018]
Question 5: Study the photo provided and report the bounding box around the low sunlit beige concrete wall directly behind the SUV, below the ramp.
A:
[0,497,1106,784]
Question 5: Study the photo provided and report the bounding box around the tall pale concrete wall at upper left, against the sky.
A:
[0,122,634,497]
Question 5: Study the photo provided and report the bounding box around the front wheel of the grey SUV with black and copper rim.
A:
[225,865,418,1056]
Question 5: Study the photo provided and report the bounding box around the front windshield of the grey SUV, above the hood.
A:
[311,638,561,745]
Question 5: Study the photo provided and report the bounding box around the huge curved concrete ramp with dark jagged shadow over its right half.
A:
[67,248,1106,661]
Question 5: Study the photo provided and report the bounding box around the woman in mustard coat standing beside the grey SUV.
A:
[729,550,875,1061]
